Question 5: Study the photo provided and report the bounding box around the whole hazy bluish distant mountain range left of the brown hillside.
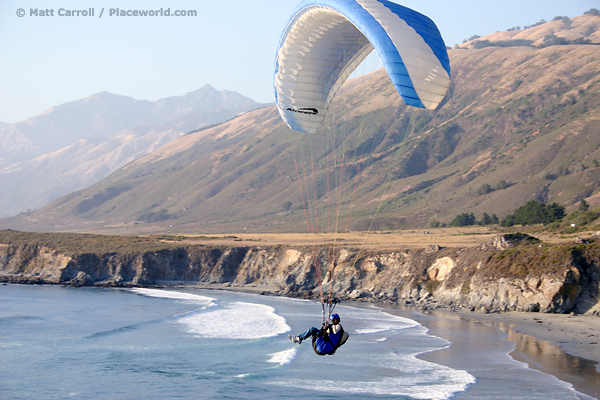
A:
[0,85,268,216]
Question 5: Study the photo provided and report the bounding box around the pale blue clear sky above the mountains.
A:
[0,0,599,123]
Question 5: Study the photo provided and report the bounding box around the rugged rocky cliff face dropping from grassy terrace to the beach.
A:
[0,235,600,315]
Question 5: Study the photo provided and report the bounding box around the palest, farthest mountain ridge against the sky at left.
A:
[0,85,256,159]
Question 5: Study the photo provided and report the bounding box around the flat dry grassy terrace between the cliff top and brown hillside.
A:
[0,226,600,254]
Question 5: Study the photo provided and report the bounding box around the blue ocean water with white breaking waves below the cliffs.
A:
[0,285,582,399]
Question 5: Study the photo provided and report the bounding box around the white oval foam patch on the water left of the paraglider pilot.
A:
[178,302,291,339]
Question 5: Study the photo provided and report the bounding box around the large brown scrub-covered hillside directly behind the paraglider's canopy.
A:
[0,16,600,232]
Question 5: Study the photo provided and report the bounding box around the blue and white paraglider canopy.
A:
[275,0,450,133]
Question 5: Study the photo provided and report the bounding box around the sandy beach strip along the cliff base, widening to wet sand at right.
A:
[3,283,600,399]
